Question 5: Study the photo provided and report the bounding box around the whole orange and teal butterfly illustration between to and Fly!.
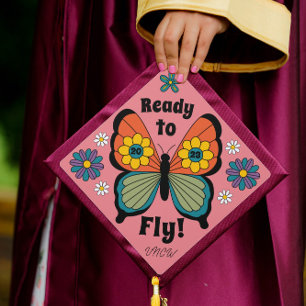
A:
[110,109,222,228]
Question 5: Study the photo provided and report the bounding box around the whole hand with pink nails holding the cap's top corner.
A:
[154,11,229,83]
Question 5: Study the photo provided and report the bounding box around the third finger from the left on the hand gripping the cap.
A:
[176,24,200,83]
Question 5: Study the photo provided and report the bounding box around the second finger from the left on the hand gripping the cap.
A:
[164,17,185,73]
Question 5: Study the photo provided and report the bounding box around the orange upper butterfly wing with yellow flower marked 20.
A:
[110,109,160,172]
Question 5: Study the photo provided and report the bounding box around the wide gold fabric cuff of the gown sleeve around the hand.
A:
[136,0,291,72]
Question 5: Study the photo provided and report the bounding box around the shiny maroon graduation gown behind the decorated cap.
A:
[10,0,306,306]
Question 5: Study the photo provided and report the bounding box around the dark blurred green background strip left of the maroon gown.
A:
[0,0,37,306]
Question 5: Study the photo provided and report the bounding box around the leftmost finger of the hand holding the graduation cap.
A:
[154,16,170,71]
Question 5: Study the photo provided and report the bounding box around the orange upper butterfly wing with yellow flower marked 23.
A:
[170,114,222,175]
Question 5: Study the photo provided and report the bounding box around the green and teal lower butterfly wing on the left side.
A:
[115,172,161,223]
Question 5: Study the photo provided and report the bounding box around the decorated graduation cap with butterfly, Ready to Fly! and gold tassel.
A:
[46,64,286,305]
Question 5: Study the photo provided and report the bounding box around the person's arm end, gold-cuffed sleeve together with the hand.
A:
[137,0,291,78]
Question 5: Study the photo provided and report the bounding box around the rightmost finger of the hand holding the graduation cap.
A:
[190,30,215,73]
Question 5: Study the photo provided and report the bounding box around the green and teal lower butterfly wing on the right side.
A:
[169,173,213,228]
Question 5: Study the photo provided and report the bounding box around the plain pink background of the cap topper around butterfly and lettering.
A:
[60,72,270,274]
